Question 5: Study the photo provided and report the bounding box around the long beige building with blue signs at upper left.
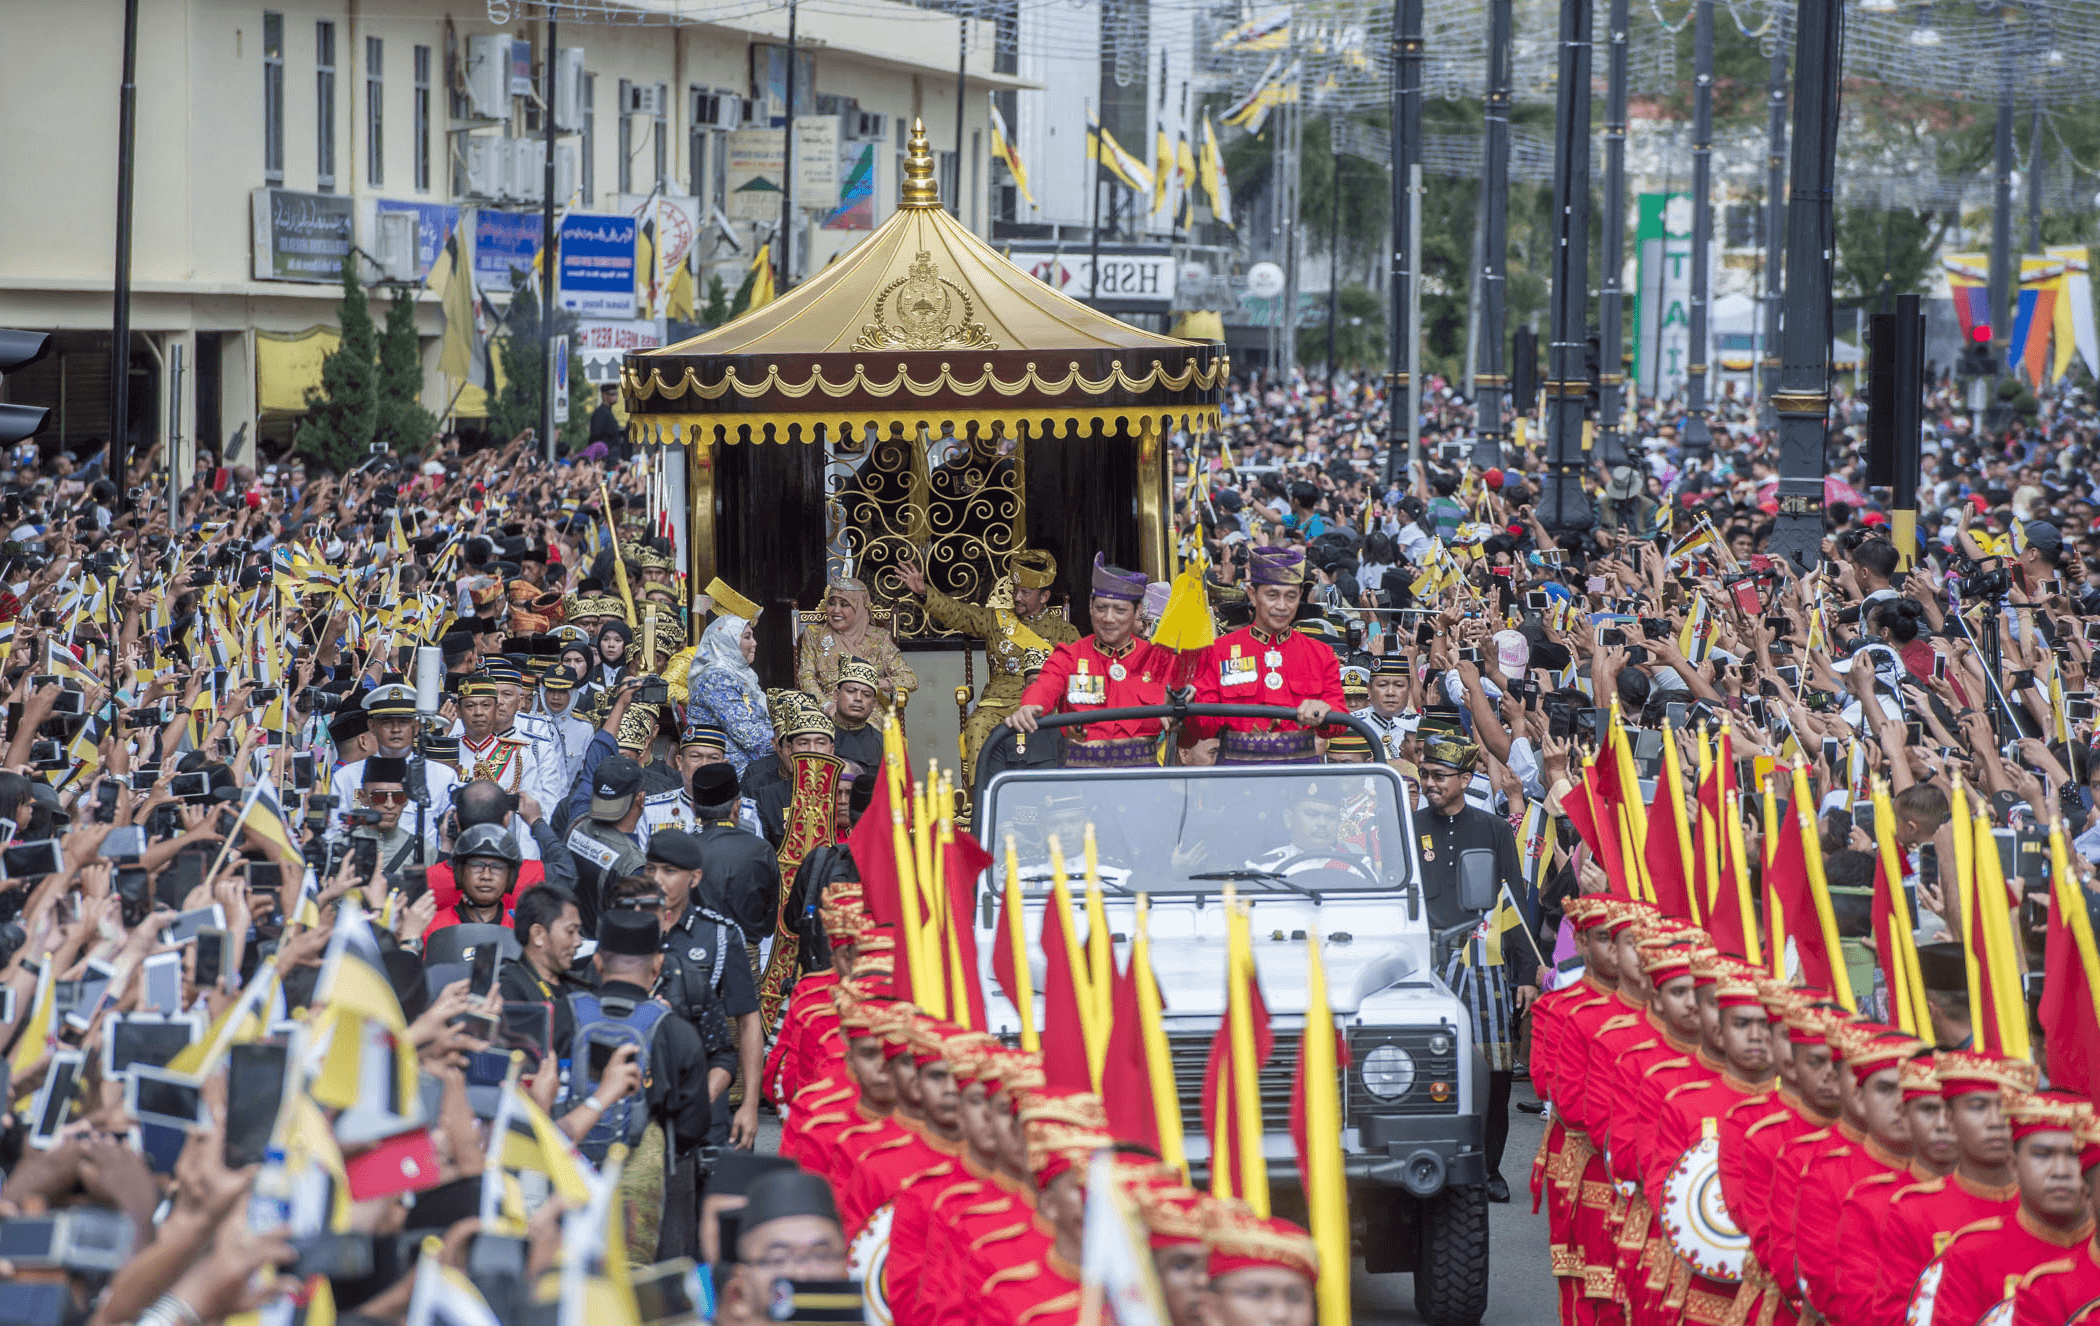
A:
[0,0,1029,468]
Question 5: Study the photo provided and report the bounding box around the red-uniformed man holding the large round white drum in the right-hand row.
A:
[1642,950,1772,1326]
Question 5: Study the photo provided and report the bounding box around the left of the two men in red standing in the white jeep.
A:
[1006,553,1174,769]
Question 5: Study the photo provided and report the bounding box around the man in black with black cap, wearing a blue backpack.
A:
[588,904,714,1261]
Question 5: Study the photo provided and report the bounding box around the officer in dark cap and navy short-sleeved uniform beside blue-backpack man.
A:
[647,828,767,1147]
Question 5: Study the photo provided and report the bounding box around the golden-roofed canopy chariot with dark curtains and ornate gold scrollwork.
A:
[622,124,1229,781]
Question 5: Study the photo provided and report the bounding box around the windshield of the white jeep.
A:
[985,765,1413,893]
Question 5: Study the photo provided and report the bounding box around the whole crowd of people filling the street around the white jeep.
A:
[0,350,2100,1326]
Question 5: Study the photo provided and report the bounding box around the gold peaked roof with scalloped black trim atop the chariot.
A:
[622,124,1231,441]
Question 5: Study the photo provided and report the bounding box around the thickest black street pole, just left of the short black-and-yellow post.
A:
[1772,0,1847,576]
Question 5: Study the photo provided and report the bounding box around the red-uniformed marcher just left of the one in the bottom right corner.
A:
[1865,1051,2039,1326]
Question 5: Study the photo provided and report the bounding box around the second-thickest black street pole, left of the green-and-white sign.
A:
[1539,0,1587,534]
